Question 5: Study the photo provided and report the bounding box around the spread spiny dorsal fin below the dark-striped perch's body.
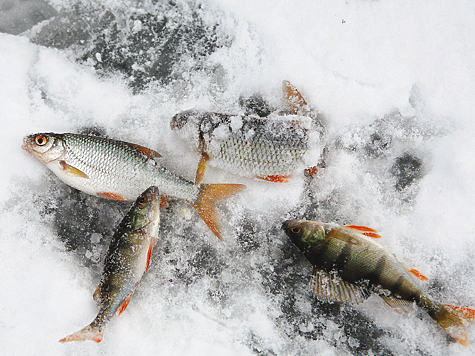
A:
[310,269,370,304]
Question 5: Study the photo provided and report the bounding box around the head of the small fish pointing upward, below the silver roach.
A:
[130,186,160,230]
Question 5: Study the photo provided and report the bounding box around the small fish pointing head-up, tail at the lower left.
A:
[59,187,160,342]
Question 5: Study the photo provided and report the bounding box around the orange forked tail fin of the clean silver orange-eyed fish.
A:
[192,184,245,240]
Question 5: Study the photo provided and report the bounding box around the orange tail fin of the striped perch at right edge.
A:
[434,305,475,346]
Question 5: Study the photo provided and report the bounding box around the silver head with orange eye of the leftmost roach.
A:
[21,133,66,165]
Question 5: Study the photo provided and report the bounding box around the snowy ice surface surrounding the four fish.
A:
[0,1,475,355]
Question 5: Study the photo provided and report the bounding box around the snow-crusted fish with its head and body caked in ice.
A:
[170,81,325,183]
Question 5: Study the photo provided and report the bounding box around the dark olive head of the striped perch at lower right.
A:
[282,220,326,251]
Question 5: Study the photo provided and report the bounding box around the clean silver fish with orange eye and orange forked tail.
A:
[22,133,244,239]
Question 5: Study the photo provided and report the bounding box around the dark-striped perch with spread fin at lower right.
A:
[282,220,475,346]
